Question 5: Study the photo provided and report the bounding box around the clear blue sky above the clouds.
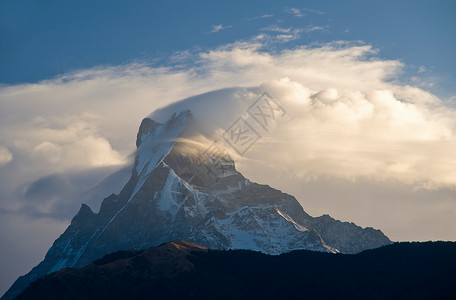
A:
[0,0,456,96]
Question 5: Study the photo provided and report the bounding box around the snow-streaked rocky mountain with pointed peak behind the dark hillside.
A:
[2,110,391,299]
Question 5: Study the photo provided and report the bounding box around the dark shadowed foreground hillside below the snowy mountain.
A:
[17,241,456,299]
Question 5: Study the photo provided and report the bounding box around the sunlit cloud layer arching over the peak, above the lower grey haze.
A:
[0,41,456,204]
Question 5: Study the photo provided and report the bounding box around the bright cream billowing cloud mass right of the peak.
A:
[244,78,456,188]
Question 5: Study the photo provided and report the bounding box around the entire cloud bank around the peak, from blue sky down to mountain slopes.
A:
[0,39,456,296]
